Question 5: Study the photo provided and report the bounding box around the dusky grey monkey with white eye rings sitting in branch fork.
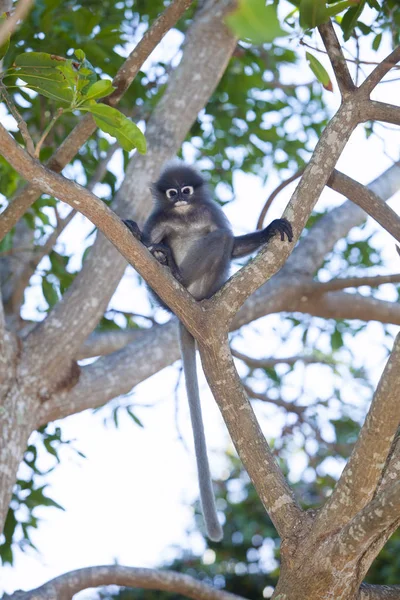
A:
[124,163,293,541]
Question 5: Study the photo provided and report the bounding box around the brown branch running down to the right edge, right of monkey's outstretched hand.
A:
[328,169,400,242]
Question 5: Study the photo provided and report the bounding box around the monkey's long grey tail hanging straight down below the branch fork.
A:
[179,323,223,542]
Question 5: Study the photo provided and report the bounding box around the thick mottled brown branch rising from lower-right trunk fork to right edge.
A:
[317,334,400,531]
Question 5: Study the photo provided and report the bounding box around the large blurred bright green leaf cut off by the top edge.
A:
[225,0,287,44]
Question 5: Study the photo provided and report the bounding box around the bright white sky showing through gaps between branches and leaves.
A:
[0,5,400,600]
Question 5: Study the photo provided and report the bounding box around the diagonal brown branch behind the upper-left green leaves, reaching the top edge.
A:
[0,0,193,240]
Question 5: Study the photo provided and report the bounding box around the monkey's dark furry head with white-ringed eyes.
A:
[151,163,207,208]
